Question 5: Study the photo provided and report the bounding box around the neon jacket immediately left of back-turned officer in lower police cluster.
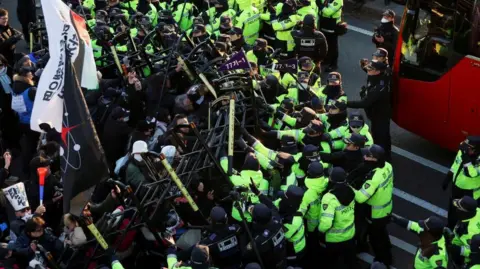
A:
[299,177,328,230]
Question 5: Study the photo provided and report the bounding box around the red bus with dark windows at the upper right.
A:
[392,0,480,150]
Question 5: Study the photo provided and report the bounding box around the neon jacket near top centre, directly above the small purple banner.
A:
[235,6,260,46]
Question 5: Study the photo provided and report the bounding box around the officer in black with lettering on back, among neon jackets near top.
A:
[292,14,328,65]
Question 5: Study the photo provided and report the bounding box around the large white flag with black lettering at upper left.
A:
[30,0,98,132]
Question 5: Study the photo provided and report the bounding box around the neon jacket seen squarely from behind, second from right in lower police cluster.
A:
[318,188,355,243]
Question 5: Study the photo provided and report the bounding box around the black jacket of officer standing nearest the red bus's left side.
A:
[347,74,391,121]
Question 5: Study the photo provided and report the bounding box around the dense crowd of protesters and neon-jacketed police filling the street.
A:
[0,0,480,269]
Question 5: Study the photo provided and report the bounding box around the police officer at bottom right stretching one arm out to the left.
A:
[392,214,448,269]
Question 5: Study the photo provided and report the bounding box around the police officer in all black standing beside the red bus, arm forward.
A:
[347,61,392,160]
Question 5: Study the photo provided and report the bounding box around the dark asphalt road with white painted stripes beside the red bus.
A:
[1,0,454,269]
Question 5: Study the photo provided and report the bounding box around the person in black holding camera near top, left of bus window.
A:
[372,9,398,65]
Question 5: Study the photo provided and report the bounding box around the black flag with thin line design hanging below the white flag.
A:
[60,49,109,216]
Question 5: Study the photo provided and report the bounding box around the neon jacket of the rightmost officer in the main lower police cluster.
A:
[355,162,393,219]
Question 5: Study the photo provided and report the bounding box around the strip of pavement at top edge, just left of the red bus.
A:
[344,0,405,22]
